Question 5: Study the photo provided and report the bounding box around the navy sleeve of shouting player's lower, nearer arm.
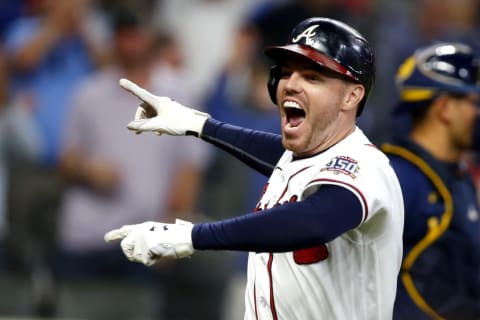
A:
[192,185,363,252]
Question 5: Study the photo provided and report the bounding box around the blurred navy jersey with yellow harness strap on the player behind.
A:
[383,137,480,320]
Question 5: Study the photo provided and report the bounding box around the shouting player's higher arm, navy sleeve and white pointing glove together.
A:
[120,79,285,176]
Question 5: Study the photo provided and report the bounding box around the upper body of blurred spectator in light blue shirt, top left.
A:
[5,0,108,167]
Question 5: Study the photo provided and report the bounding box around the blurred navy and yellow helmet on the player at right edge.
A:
[395,42,480,112]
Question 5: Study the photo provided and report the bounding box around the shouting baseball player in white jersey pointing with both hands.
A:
[105,18,403,320]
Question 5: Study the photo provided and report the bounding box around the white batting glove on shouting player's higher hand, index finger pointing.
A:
[120,79,210,137]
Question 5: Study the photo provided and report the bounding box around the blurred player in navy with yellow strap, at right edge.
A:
[383,42,480,320]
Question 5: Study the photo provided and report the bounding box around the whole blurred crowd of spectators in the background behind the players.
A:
[0,0,480,320]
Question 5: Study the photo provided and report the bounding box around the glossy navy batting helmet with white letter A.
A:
[265,17,375,116]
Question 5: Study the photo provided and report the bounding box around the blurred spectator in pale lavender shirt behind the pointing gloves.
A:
[57,7,207,319]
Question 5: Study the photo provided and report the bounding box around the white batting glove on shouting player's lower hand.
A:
[105,219,194,266]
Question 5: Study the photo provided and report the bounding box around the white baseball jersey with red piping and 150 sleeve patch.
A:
[245,128,403,320]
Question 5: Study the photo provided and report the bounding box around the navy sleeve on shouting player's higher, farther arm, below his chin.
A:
[201,118,285,177]
